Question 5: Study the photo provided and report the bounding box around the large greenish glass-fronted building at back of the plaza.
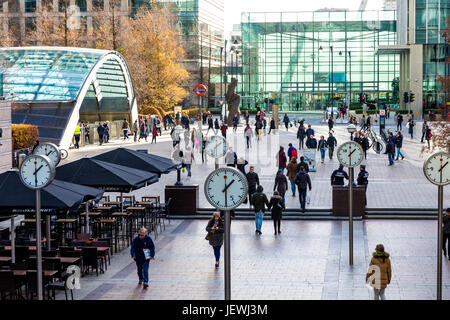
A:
[238,11,400,111]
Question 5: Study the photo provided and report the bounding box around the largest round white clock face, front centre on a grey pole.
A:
[205,167,248,210]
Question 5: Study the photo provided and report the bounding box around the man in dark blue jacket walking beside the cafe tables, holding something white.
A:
[131,228,155,289]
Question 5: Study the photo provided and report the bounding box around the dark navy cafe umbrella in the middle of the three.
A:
[56,157,158,220]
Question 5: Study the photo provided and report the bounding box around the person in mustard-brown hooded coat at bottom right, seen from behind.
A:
[366,244,392,300]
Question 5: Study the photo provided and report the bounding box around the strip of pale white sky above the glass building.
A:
[224,0,383,36]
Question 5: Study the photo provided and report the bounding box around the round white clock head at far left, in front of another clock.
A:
[19,154,55,189]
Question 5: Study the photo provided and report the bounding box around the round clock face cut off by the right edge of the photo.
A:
[423,152,450,186]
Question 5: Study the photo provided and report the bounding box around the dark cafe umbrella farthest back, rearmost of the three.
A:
[93,148,181,177]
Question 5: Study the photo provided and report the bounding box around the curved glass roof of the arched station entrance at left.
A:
[0,47,120,101]
